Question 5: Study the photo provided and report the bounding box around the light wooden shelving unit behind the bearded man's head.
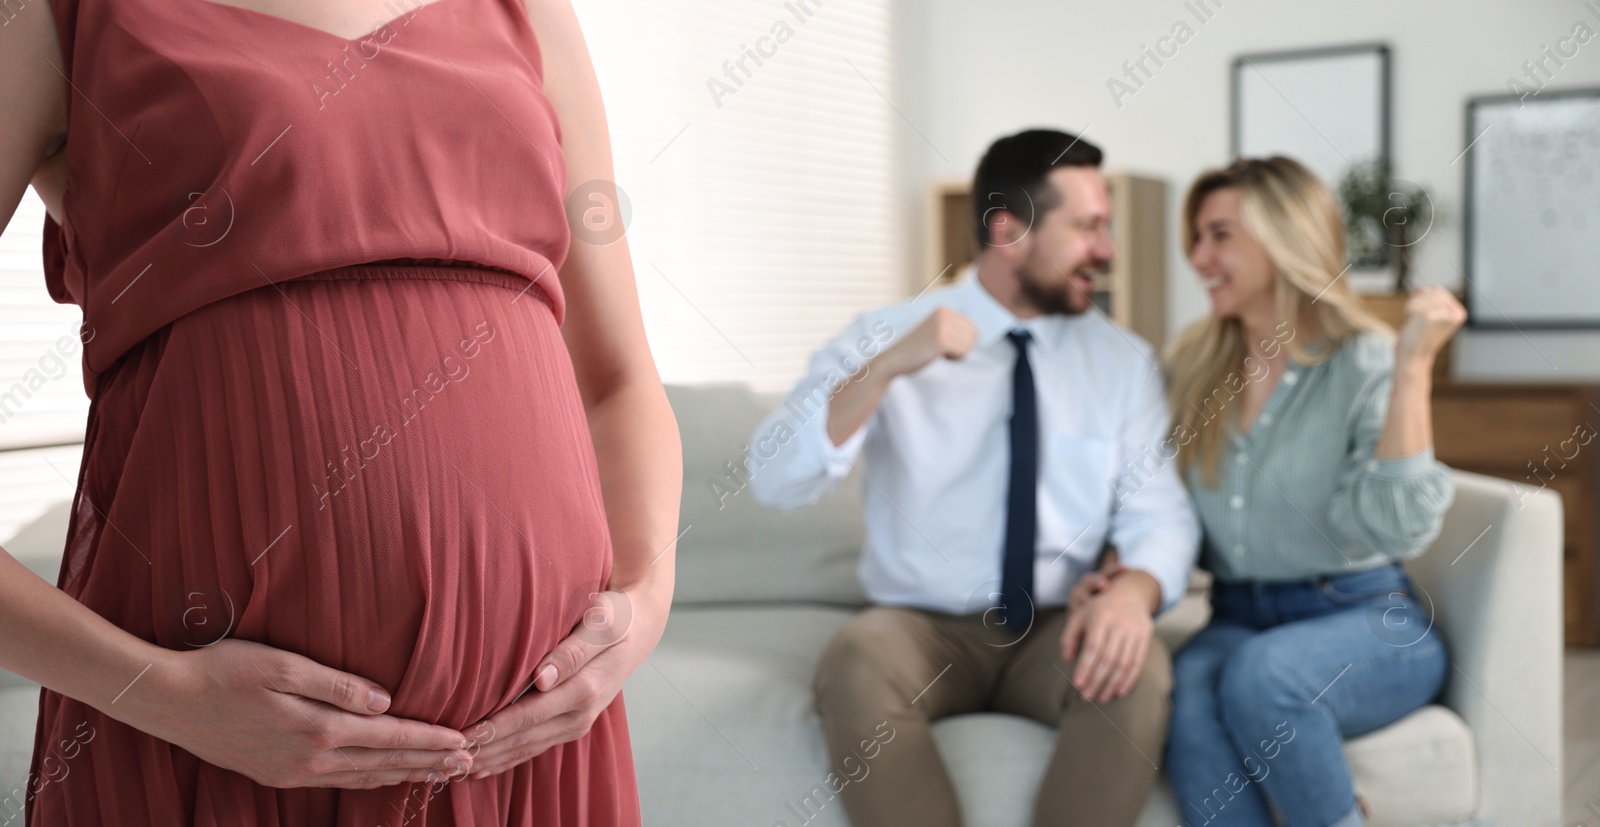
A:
[928,173,1166,352]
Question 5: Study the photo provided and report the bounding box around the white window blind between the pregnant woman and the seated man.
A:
[570,0,902,390]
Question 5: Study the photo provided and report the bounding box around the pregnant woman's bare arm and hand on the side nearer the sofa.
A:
[460,0,683,776]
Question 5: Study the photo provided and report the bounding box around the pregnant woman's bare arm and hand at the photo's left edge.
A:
[0,0,470,787]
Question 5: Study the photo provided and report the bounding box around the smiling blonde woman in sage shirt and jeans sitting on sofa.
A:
[1166,157,1466,827]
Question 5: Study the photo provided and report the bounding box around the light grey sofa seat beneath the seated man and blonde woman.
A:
[624,595,1477,827]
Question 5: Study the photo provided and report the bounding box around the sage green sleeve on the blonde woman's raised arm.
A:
[1328,371,1456,561]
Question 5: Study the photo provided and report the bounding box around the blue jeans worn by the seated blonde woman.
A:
[1166,565,1450,827]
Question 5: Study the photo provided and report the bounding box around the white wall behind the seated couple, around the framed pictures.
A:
[896,0,1600,381]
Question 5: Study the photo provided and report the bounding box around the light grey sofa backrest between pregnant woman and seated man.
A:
[667,384,866,606]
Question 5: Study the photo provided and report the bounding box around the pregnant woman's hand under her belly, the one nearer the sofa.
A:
[467,590,670,779]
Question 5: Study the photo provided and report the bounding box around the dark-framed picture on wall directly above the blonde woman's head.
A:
[1232,43,1390,270]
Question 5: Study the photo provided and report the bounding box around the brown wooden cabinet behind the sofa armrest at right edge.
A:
[1434,382,1600,646]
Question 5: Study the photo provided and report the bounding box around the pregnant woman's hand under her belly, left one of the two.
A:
[128,638,472,789]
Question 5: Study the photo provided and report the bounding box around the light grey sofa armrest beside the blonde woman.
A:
[1406,470,1563,825]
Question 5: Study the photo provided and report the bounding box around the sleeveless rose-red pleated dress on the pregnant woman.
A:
[26,0,640,827]
